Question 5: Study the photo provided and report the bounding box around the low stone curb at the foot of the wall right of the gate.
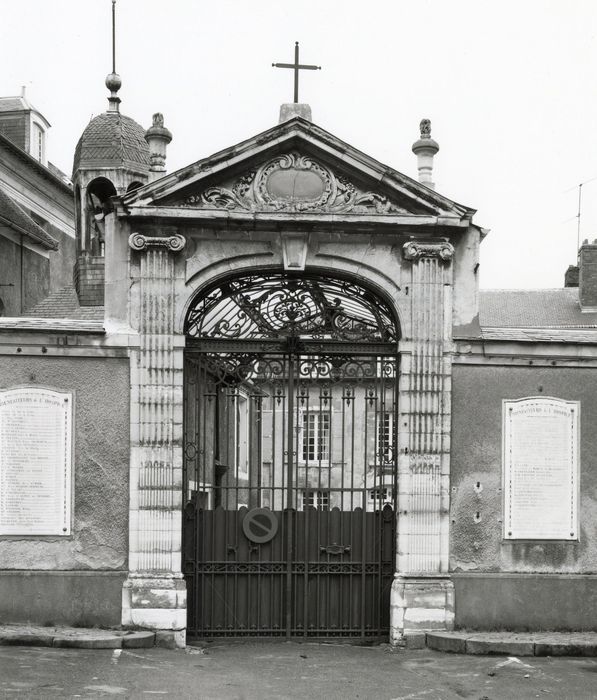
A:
[426,632,597,656]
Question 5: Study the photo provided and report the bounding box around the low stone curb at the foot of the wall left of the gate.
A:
[0,629,155,649]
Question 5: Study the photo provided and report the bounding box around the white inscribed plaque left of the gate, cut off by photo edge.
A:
[0,387,73,535]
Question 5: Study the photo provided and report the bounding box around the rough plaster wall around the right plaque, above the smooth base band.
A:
[450,365,597,573]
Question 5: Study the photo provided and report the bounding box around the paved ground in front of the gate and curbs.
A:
[0,642,597,700]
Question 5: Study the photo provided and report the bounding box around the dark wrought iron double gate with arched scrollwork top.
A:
[183,275,398,639]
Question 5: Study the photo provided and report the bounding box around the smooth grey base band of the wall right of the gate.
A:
[452,573,597,631]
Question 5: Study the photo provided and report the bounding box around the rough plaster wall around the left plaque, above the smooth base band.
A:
[0,355,129,568]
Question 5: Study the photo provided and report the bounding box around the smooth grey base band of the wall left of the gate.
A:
[0,570,127,627]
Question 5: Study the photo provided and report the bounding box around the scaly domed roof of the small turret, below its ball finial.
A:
[73,111,149,175]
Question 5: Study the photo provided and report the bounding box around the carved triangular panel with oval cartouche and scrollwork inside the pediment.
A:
[169,151,408,214]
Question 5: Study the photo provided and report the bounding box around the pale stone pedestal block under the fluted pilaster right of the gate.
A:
[390,576,454,644]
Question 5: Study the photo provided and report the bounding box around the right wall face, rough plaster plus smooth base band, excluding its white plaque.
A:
[450,365,597,629]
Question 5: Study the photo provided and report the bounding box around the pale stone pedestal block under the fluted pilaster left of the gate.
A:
[122,575,187,647]
